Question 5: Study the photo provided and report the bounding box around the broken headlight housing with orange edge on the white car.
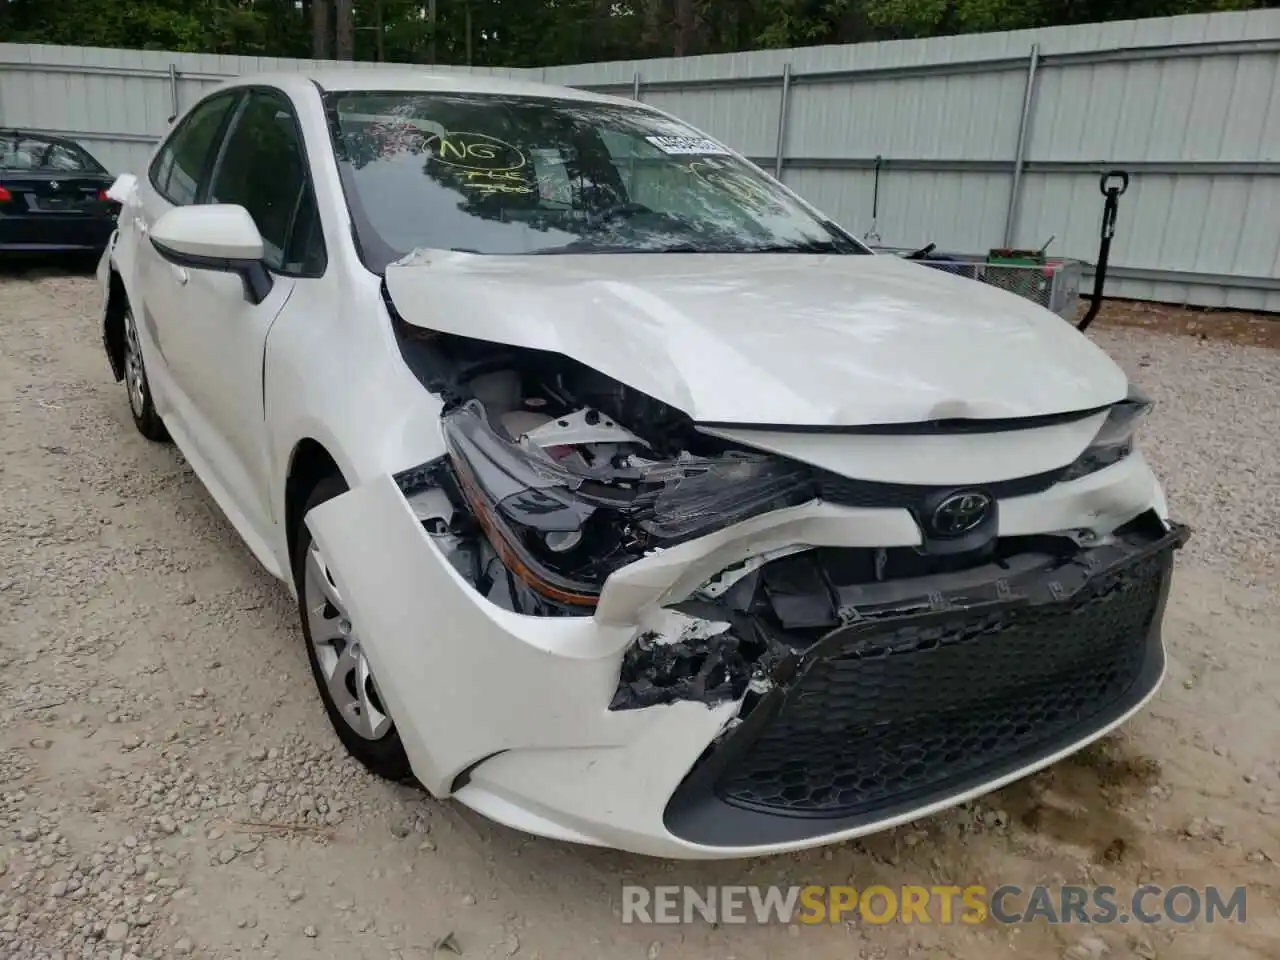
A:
[443,401,813,607]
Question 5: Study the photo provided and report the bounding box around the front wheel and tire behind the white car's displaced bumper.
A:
[293,475,413,782]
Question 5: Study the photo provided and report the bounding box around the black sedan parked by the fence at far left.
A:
[0,128,120,257]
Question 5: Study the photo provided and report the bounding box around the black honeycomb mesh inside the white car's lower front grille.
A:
[717,557,1164,817]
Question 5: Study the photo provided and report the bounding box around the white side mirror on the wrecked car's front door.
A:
[151,204,271,303]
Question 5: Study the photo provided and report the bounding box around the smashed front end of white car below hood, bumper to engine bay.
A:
[315,302,1188,855]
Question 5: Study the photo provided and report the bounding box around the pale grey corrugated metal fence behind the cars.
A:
[0,10,1280,311]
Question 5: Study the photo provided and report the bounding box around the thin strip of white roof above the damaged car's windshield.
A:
[223,67,643,106]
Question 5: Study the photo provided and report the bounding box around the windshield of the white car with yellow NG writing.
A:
[326,92,868,273]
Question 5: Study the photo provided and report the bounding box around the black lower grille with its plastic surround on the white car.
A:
[664,525,1188,846]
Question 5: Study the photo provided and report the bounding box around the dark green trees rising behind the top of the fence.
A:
[0,0,1277,67]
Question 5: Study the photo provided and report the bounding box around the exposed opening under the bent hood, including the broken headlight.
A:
[389,321,814,616]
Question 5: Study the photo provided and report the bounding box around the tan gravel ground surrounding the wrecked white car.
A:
[0,273,1280,960]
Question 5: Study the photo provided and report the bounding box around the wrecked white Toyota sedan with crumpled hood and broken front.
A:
[100,70,1187,858]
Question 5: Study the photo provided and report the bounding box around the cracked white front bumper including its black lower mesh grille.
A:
[307,454,1185,859]
